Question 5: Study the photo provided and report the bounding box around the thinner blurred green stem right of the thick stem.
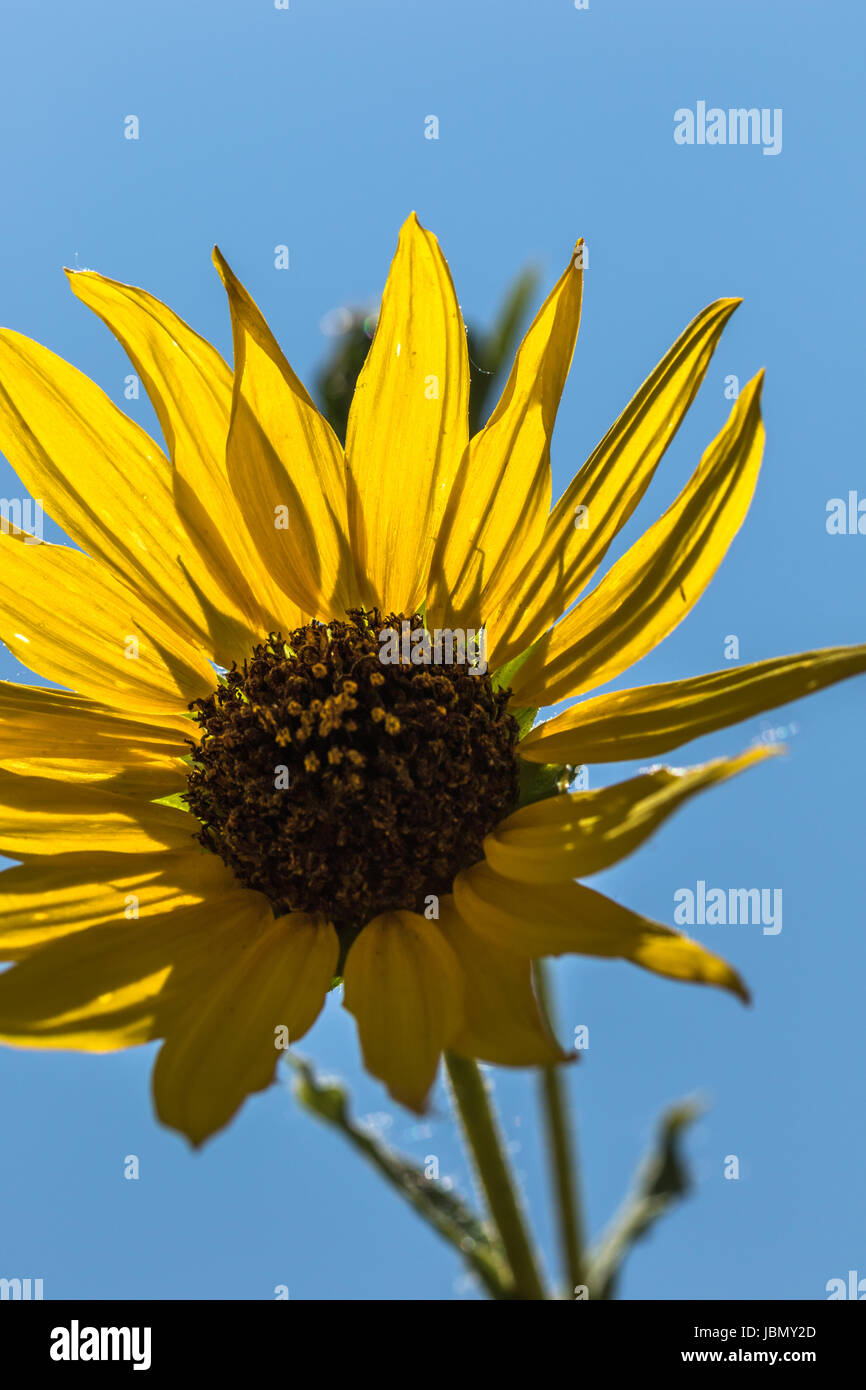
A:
[532,960,587,1293]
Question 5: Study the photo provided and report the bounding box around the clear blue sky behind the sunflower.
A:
[0,0,866,1300]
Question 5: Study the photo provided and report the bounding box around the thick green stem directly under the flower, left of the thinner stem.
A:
[445,1052,545,1300]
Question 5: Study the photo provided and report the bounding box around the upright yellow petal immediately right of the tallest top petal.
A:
[428,242,584,627]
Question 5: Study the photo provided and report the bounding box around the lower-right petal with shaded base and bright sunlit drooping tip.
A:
[455,863,748,1001]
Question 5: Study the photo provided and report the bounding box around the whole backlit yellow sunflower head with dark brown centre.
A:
[0,215,866,1144]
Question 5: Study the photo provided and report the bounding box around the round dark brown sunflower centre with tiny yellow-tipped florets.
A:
[188,609,517,930]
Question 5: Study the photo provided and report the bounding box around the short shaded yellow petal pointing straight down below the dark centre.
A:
[343,912,463,1113]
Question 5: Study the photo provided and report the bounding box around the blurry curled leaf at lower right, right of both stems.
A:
[587,1101,702,1300]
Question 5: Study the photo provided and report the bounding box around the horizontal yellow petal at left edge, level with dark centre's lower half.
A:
[0,771,200,859]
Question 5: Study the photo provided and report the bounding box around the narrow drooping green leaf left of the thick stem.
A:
[286,1054,510,1298]
